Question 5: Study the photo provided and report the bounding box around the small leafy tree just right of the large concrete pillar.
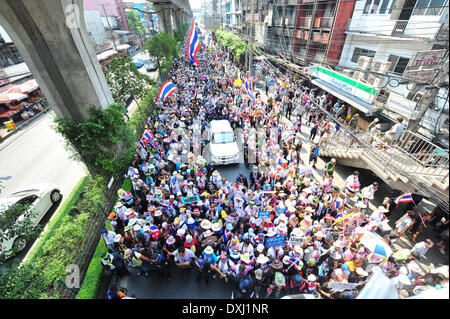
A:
[105,56,155,103]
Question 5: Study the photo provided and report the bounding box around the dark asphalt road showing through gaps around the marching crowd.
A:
[111,118,448,299]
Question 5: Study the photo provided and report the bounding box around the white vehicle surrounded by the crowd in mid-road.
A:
[209,120,239,165]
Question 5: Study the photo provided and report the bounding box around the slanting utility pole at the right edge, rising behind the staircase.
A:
[407,50,449,132]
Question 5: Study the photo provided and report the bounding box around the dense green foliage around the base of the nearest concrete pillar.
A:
[55,104,133,178]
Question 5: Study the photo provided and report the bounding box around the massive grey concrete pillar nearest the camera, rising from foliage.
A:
[0,0,114,121]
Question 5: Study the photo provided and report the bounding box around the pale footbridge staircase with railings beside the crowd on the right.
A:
[319,126,449,210]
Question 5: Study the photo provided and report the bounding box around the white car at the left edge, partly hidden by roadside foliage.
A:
[0,183,61,258]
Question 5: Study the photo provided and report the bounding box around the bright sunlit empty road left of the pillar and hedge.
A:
[0,112,86,262]
